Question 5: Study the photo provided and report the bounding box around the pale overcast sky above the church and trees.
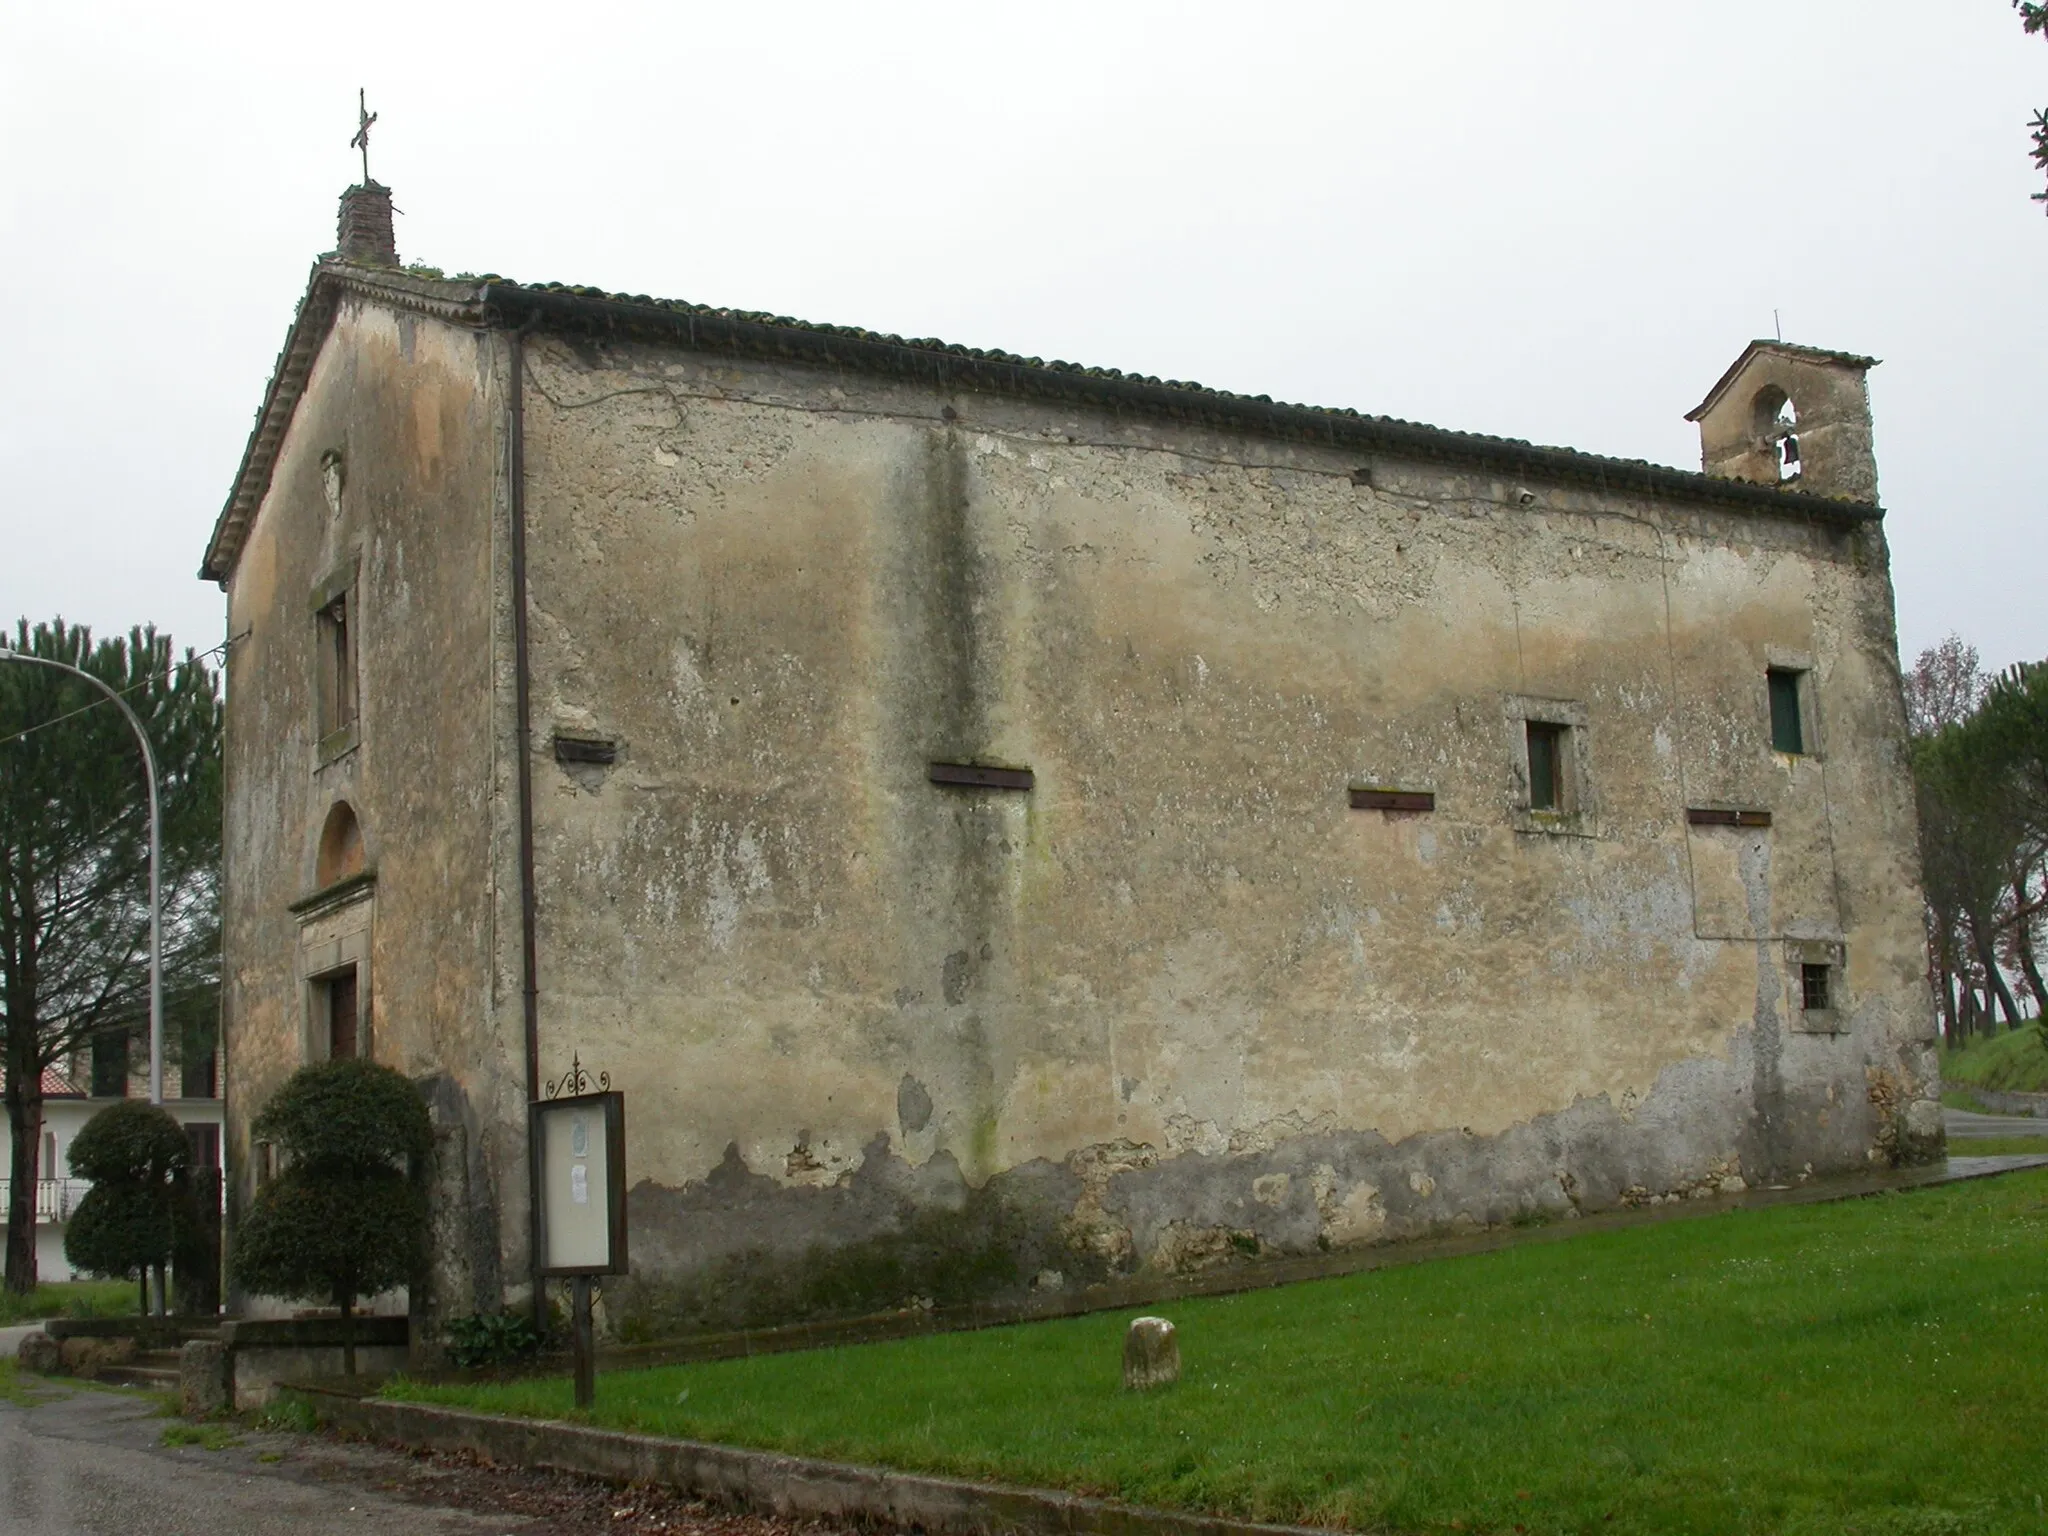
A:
[0,0,2048,666]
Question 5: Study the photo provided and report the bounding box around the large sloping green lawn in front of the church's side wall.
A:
[387,1171,2048,1536]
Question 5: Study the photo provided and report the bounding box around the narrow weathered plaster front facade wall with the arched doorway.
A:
[223,305,524,1311]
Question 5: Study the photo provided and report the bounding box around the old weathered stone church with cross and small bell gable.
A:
[201,182,1942,1337]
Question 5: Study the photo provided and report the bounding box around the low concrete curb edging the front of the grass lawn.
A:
[303,1384,1329,1536]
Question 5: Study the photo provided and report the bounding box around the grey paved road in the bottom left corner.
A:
[0,1386,549,1536]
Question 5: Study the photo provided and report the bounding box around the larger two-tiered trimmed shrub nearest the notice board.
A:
[231,1061,434,1376]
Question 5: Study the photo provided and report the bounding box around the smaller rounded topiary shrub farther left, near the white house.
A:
[63,1102,193,1313]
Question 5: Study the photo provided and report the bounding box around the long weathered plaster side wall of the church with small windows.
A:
[508,338,1939,1329]
